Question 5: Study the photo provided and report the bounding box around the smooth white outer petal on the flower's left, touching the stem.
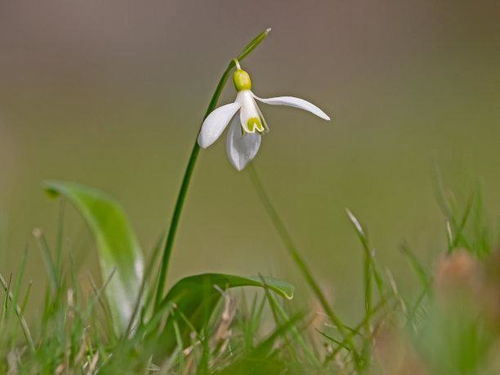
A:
[198,102,240,148]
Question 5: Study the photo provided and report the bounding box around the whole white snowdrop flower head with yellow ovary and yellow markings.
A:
[198,60,330,171]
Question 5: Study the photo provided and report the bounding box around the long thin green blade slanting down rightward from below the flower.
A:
[247,164,359,363]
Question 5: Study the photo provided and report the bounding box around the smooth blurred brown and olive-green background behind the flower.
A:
[0,0,500,322]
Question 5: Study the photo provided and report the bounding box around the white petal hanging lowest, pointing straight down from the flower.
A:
[226,118,261,171]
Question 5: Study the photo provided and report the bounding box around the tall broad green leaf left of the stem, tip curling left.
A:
[45,181,144,334]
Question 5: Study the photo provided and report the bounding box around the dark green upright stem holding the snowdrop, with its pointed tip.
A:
[155,28,271,309]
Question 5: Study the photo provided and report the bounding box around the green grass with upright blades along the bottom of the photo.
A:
[0,176,500,374]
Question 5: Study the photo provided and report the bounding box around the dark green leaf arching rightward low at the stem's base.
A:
[156,273,294,350]
